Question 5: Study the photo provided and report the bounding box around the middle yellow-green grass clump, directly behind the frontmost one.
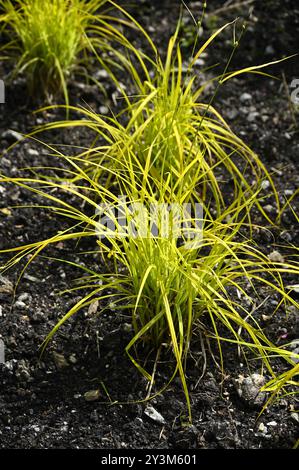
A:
[36,18,290,222]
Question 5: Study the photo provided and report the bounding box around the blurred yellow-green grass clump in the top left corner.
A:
[0,0,137,103]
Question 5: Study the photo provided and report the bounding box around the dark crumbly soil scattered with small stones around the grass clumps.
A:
[0,0,299,449]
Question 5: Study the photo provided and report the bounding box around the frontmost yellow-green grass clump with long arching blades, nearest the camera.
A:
[0,156,299,419]
